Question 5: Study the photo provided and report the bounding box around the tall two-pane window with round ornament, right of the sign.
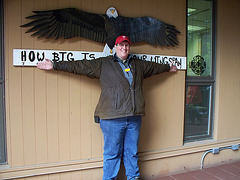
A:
[184,0,215,142]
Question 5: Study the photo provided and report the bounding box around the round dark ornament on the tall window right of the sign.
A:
[189,55,206,75]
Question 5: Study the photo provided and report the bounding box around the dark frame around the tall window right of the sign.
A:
[183,0,217,143]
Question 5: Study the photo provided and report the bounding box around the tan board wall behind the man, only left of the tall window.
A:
[3,0,186,180]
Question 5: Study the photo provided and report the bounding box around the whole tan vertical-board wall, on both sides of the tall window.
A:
[0,0,240,180]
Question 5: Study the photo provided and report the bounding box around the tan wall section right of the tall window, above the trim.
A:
[217,0,240,140]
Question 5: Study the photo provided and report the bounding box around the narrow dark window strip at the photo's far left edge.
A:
[0,1,6,164]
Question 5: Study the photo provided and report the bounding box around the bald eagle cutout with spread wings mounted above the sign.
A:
[21,7,180,55]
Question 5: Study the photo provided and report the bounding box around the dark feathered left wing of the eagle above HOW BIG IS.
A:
[21,8,107,43]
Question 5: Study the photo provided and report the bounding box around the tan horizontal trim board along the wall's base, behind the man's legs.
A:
[0,138,240,180]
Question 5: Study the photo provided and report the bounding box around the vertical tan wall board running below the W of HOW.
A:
[31,0,48,164]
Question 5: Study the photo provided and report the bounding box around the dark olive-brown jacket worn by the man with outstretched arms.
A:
[54,56,170,119]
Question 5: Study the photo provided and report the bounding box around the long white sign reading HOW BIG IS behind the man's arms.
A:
[13,49,186,70]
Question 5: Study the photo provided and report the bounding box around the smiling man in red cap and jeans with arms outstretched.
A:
[37,36,177,180]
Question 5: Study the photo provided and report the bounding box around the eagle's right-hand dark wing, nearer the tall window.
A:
[106,16,180,46]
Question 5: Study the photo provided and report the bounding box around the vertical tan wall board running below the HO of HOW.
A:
[20,1,36,165]
